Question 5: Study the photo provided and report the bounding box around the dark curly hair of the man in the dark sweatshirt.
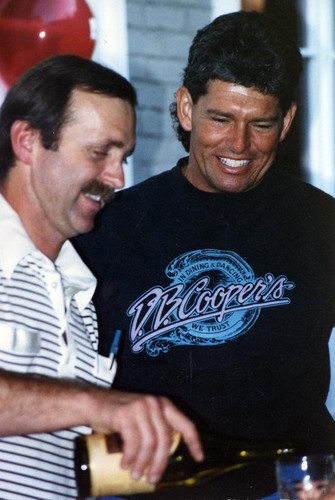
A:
[170,11,302,151]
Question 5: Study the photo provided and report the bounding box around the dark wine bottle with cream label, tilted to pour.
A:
[75,433,298,498]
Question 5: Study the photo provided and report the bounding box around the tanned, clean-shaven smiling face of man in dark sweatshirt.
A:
[177,80,296,193]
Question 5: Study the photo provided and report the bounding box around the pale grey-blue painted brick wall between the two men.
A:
[127,0,211,183]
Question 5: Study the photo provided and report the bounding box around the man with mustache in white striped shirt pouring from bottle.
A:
[0,55,202,499]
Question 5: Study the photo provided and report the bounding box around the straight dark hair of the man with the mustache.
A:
[0,54,137,181]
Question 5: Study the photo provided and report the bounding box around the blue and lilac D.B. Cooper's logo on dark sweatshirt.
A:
[127,249,295,356]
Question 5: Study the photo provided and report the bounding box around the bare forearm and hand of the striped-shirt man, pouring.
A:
[0,371,202,482]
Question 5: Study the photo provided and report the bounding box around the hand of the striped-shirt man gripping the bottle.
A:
[84,391,203,483]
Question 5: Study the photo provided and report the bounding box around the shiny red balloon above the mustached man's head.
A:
[0,0,95,86]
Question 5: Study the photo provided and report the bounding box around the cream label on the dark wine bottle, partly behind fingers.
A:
[86,433,180,496]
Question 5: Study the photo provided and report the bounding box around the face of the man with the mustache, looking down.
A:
[26,90,135,241]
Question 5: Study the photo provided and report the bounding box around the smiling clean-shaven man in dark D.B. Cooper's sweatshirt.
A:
[78,12,335,500]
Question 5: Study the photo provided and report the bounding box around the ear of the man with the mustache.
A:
[10,120,39,165]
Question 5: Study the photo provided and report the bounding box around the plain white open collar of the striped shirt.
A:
[0,194,96,310]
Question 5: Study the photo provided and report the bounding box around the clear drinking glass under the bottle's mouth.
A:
[276,454,335,500]
